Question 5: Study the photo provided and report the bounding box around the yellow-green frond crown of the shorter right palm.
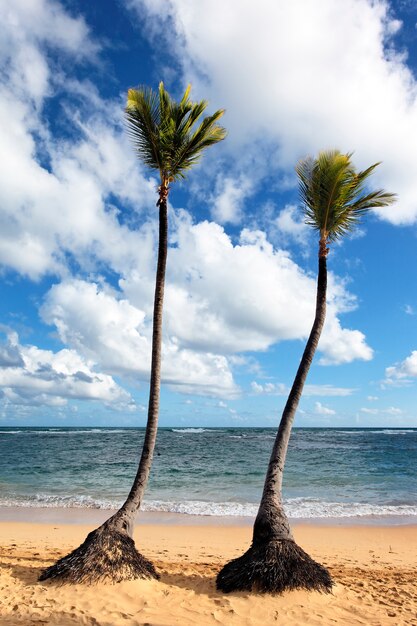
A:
[296,150,396,255]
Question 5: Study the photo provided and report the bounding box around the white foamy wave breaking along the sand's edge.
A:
[0,494,417,519]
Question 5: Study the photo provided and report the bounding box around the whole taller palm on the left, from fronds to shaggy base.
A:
[40,82,226,583]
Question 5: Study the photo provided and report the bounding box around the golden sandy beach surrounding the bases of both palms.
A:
[0,512,417,626]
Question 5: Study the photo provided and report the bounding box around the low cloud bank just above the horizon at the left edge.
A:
[0,329,134,410]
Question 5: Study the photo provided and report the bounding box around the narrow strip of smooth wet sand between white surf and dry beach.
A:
[0,506,417,528]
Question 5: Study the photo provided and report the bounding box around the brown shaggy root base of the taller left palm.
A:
[39,524,159,584]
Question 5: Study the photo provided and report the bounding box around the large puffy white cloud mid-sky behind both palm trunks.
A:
[37,212,371,396]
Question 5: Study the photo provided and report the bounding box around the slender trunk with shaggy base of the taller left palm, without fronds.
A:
[39,183,169,583]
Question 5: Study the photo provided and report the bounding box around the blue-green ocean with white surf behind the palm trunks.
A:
[0,427,417,523]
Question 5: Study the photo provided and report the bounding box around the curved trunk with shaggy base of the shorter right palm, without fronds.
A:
[217,246,333,593]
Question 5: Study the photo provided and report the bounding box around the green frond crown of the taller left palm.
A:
[126,82,226,185]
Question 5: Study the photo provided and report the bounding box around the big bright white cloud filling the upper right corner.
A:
[132,0,417,224]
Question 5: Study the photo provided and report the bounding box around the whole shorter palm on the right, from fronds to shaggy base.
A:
[217,150,395,593]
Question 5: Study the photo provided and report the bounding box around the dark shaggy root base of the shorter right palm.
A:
[216,539,334,593]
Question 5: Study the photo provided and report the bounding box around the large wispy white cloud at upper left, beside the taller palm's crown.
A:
[0,0,155,279]
